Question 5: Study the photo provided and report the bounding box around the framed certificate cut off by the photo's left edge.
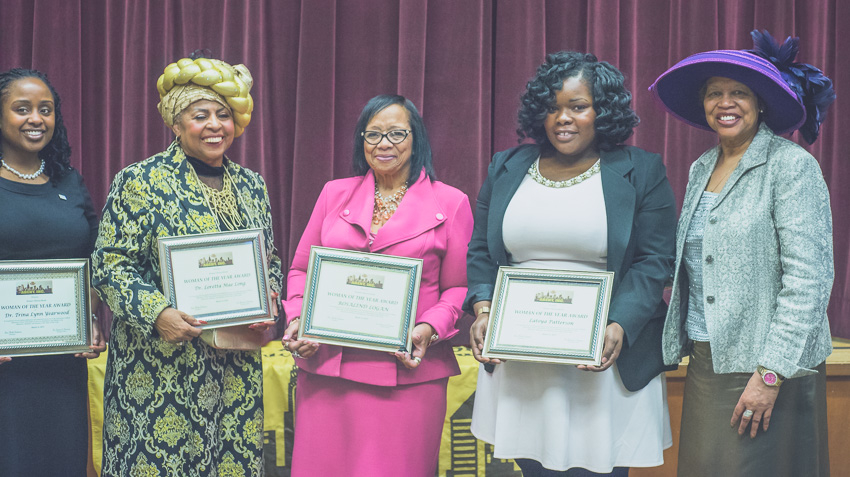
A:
[0,259,92,356]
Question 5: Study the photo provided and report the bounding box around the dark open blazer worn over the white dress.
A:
[464,144,676,391]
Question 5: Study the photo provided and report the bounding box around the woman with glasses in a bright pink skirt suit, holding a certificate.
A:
[283,95,473,477]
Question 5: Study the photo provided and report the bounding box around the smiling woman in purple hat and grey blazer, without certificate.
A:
[650,31,835,476]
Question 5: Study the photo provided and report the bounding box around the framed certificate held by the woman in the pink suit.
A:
[298,246,422,352]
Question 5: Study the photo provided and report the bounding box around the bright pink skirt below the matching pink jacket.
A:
[292,370,449,477]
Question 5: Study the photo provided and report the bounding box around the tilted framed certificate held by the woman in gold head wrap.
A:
[159,229,273,329]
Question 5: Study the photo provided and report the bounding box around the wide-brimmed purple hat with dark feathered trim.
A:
[649,30,835,144]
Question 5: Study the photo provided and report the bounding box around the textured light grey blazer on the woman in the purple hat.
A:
[663,123,833,378]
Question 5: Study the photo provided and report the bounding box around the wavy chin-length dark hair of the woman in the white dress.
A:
[517,51,640,151]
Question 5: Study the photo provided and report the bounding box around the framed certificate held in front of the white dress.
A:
[482,267,614,366]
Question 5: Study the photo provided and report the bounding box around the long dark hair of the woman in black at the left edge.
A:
[0,68,71,184]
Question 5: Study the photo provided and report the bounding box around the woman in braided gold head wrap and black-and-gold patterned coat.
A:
[92,54,281,476]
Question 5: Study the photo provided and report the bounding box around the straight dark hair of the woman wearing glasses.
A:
[353,94,437,185]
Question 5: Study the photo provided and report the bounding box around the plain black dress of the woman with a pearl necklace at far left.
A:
[0,167,98,476]
